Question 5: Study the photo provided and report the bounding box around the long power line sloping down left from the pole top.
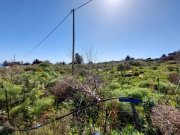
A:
[27,11,72,54]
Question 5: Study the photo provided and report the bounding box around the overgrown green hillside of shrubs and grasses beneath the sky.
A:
[0,51,180,135]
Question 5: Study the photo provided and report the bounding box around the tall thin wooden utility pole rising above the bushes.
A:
[72,9,75,75]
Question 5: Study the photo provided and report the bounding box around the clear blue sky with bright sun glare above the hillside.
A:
[0,0,180,63]
